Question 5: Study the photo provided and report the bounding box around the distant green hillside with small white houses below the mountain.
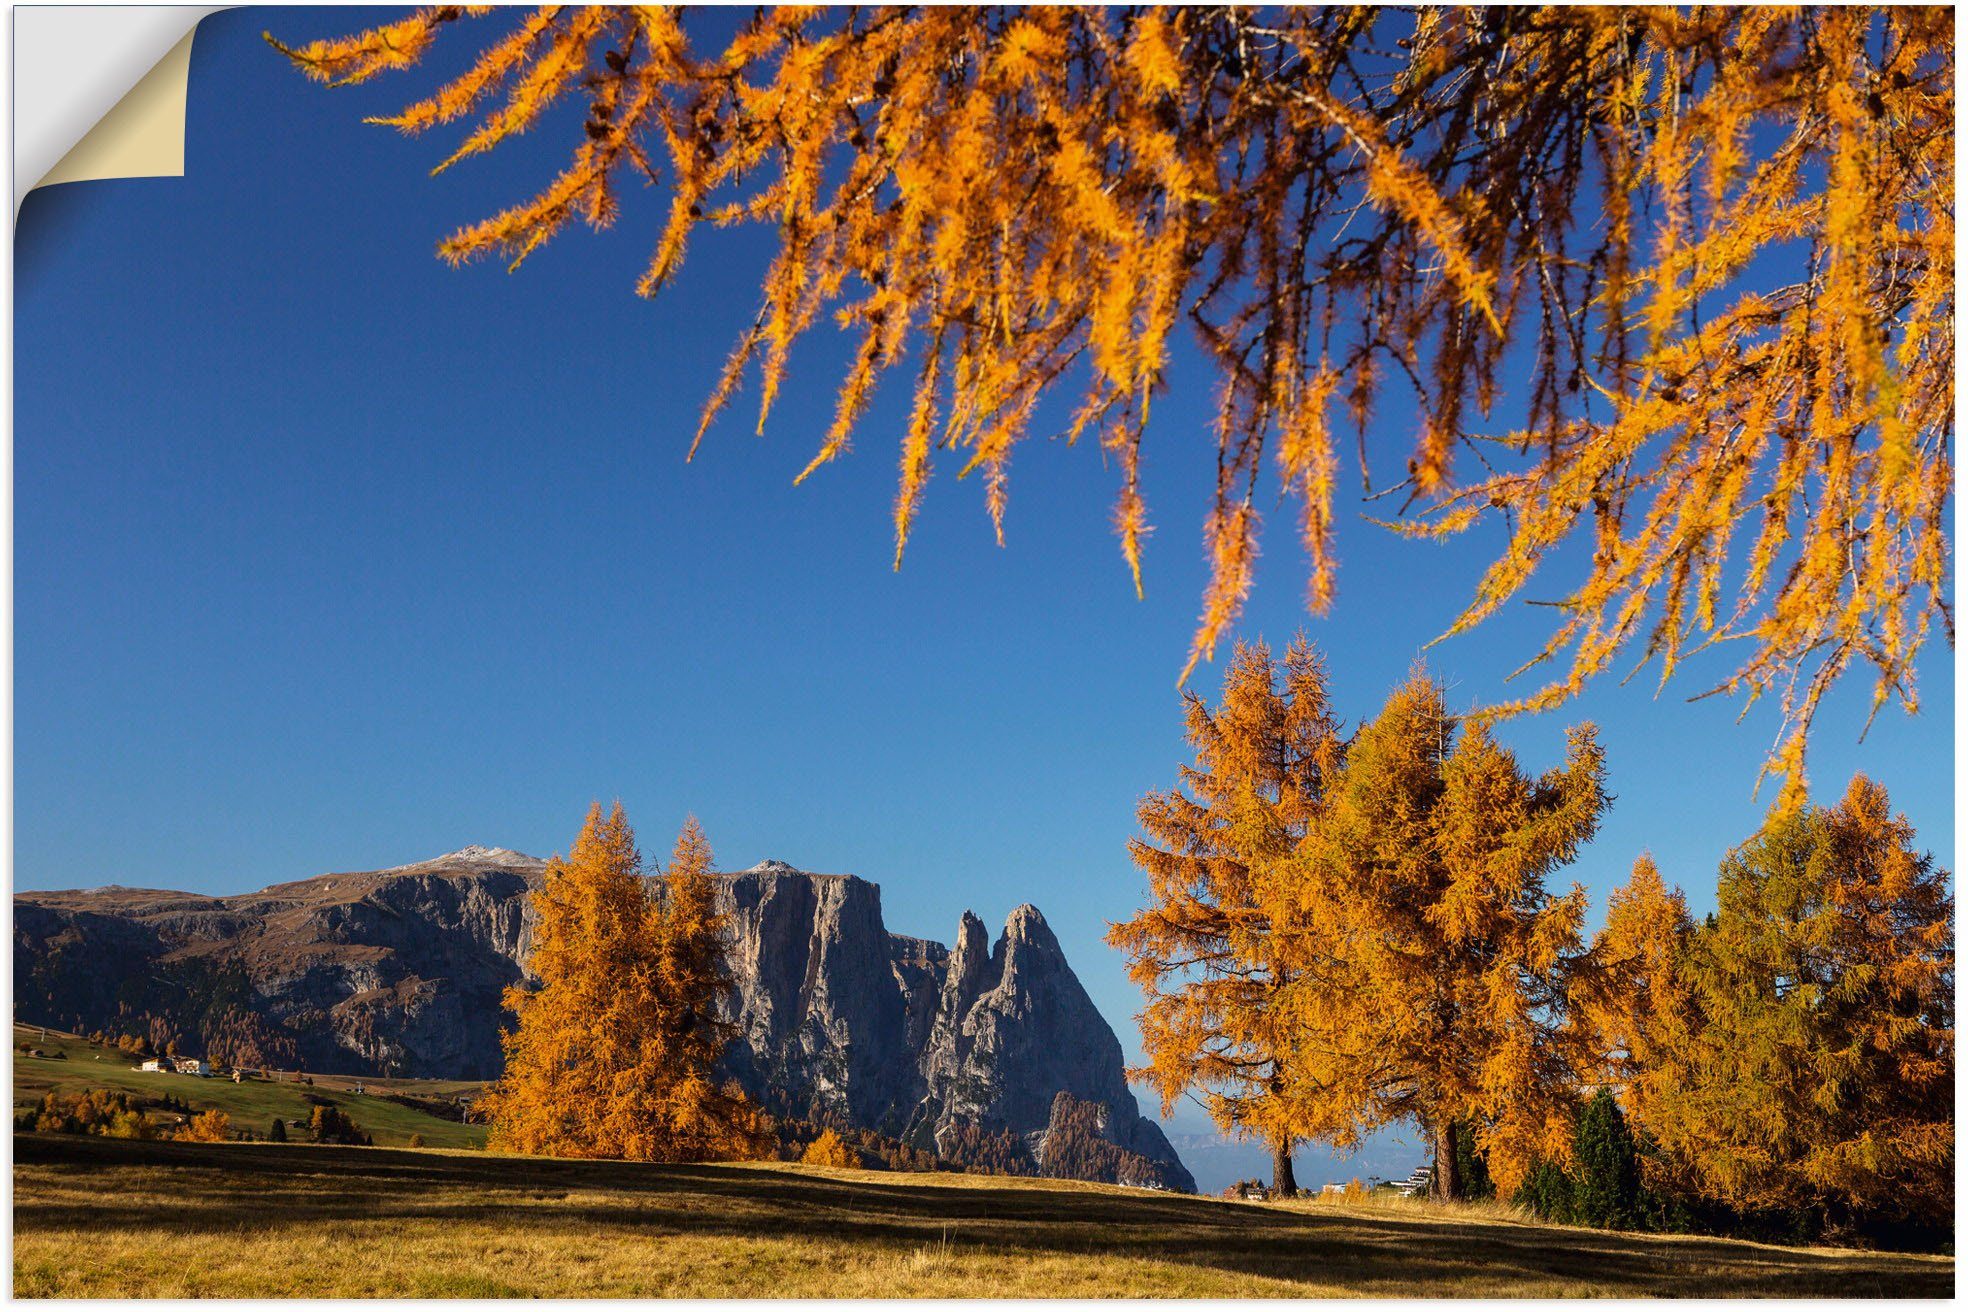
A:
[14,1025,486,1149]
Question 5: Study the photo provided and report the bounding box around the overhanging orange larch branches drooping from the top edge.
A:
[268,6,1954,805]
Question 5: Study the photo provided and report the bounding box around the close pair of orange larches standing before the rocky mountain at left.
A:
[482,803,744,1161]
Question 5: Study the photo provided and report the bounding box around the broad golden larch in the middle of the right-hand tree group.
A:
[1277,669,1608,1198]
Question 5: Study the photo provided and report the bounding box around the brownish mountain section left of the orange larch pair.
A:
[14,848,545,1080]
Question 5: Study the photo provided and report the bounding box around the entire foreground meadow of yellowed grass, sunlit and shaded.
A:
[14,1135,1954,1298]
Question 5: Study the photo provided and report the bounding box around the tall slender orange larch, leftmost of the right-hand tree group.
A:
[1108,637,1342,1196]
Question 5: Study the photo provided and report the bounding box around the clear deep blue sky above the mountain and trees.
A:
[16,10,1954,1156]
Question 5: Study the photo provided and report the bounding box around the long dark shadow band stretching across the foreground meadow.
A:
[14,1135,1954,1296]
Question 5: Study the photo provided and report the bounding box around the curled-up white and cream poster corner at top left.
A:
[14,6,216,212]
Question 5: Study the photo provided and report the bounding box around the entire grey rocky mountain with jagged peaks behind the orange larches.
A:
[14,848,1195,1190]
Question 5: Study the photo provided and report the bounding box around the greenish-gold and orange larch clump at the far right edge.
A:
[1643,775,1954,1227]
